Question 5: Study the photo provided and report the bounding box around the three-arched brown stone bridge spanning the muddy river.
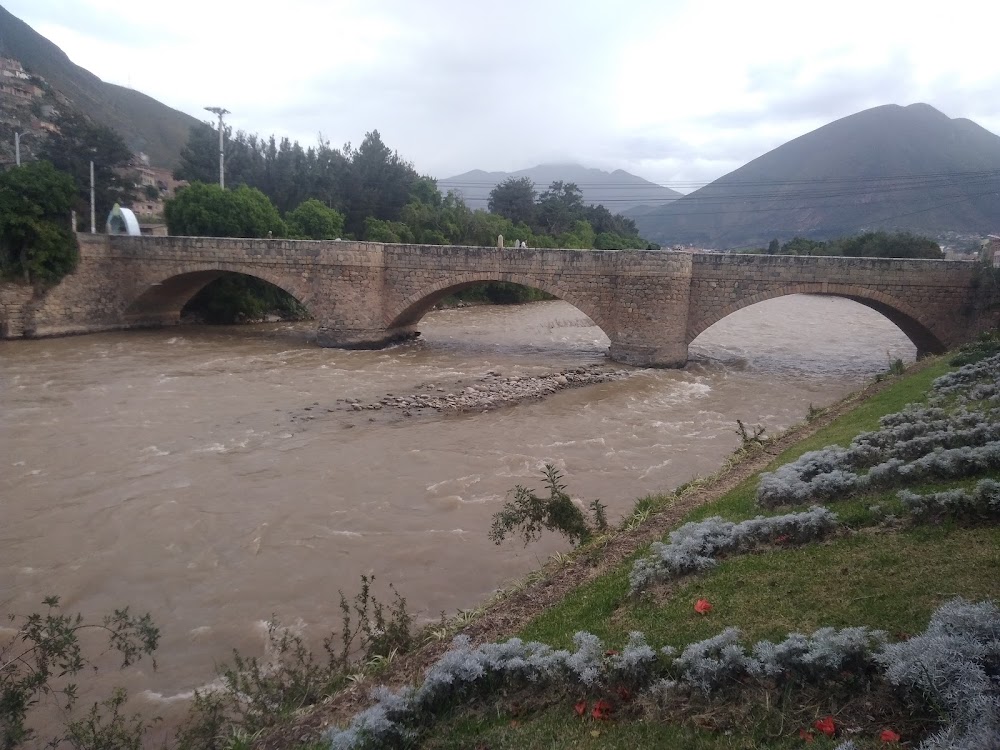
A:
[0,235,986,367]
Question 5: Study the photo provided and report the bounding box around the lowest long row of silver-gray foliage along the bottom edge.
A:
[327,600,1000,750]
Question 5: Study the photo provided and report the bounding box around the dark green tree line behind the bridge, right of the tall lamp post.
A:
[167,125,649,250]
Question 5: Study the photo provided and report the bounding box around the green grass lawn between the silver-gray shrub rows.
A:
[422,360,1000,750]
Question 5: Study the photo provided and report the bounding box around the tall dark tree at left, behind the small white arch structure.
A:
[39,112,136,224]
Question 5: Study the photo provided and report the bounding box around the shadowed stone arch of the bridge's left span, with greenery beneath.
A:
[122,264,313,327]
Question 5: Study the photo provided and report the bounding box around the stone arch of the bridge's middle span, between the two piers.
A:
[385,272,615,339]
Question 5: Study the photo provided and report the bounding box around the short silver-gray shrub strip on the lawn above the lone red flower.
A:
[629,506,837,593]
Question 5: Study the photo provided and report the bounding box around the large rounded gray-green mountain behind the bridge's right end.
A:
[627,104,1000,247]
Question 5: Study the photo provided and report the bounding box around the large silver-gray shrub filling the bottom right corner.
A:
[876,599,1000,750]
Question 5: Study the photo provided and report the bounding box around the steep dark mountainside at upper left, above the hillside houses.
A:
[0,7,199,168]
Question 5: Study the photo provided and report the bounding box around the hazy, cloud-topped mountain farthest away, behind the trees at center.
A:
[438,164,681,214]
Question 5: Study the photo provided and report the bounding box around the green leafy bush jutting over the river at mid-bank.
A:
[490,464,608,547]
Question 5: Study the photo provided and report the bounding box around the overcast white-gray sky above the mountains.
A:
[0,0,1000,192]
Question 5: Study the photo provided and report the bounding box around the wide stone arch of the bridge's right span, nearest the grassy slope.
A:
[687,282,948,355]
